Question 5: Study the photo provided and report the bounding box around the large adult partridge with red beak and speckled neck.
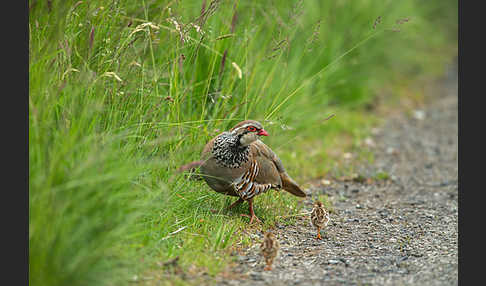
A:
[179,120,306,224]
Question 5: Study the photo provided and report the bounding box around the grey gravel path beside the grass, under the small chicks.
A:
[218,65,458,285]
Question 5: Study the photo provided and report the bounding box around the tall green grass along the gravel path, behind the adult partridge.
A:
[29,0,457,285]
